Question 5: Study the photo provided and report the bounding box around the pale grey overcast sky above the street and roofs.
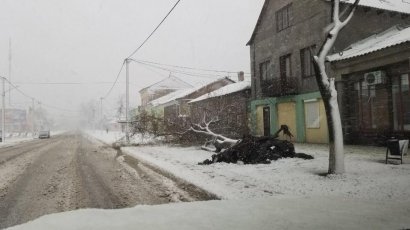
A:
[0,0,263,122]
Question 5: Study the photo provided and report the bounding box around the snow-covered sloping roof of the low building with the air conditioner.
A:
[327,26,410,62]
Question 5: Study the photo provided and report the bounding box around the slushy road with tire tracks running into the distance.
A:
[0,134,211,228]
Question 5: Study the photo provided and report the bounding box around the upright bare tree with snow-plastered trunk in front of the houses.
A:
[314,0,360,174]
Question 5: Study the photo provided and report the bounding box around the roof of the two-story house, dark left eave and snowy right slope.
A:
[246,0,410,46]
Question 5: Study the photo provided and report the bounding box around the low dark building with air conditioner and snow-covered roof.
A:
[328,26,410,144]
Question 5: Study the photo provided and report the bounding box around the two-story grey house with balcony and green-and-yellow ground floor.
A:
[248,0,410,143]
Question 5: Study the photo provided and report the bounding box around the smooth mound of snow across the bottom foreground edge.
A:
[10,197,410,230]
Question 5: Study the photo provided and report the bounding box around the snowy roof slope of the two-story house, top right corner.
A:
[341,0,410,14]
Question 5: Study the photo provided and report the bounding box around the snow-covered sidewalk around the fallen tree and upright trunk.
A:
[85,131,410,202]
